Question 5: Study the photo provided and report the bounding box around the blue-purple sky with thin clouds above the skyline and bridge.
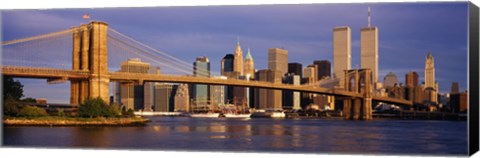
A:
[2,2,468,103]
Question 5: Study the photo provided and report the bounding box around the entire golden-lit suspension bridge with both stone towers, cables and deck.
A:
[2,21,412,120]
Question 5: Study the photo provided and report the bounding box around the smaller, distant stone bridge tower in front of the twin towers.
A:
[343,69,373,120]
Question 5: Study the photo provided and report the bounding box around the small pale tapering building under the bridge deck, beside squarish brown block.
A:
[174,84,191,112]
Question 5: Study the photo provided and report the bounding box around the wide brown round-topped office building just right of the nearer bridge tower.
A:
[114,58,151,111]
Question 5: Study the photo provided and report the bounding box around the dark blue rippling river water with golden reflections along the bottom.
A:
[3,117,467,156]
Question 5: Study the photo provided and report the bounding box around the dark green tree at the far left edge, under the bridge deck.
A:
[3,76,23,100]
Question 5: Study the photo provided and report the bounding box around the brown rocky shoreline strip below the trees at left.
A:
[3,117,150,127]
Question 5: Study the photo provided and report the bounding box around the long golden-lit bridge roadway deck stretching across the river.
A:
[2,66,412,106]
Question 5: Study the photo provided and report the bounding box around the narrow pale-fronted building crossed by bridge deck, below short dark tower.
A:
[282,73,301,110]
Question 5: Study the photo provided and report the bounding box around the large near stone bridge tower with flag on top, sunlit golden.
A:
[70,21,110,105]
